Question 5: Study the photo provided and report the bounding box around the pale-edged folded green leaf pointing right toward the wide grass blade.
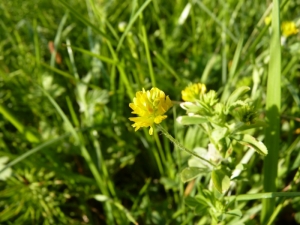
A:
[230,134,268,156]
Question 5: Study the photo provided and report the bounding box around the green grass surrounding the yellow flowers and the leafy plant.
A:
[0,0,300,225]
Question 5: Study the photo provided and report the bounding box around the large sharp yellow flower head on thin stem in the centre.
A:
[129,88,173,135]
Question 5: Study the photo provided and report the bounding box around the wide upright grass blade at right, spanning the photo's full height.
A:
[261,0,281,224]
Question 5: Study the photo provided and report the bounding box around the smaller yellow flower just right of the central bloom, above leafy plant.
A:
[181,83,206,102]
